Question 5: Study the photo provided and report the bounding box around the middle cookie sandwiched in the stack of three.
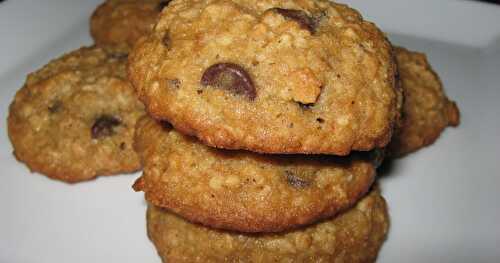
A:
[134,117,376,232]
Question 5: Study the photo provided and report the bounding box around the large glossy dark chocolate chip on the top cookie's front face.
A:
[200,63,257,100]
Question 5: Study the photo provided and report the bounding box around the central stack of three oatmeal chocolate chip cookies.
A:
[128,0,402,262]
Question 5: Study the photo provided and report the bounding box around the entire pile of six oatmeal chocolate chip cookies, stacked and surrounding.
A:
[8,0,459,262]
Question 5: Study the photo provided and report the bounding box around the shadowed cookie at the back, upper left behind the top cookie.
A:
[90,0,174,53]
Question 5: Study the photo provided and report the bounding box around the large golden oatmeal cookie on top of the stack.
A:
[129,0,399,155]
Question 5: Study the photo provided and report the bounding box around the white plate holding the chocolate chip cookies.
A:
[0,0,500,263]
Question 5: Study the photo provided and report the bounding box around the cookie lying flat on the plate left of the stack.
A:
[8,47,144,183]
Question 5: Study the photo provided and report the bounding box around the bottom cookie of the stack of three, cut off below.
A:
[147,190,389,262]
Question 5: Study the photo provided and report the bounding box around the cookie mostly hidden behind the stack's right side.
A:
[388,47,460,156]
